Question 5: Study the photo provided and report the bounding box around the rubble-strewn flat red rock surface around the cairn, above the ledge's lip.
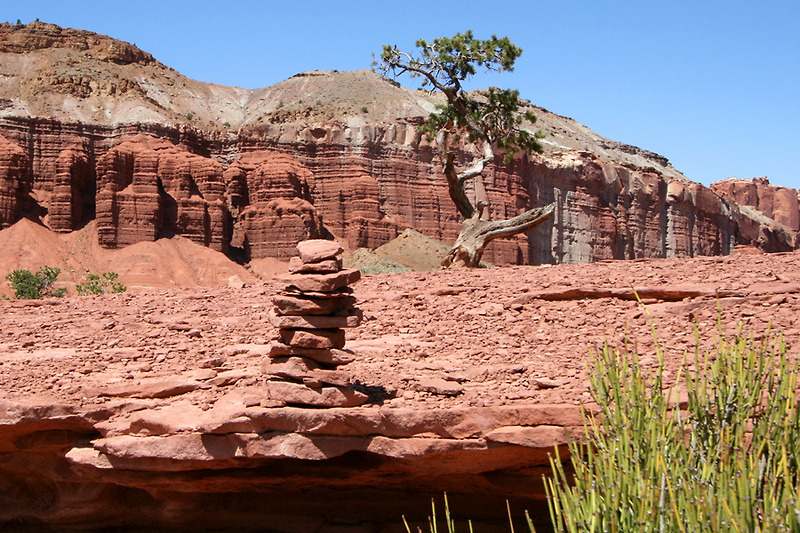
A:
[0,249,800,409]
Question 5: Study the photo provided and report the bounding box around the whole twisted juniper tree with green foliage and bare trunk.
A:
[376,31,554,267]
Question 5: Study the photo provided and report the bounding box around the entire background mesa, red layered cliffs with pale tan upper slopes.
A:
[0,22,800,264]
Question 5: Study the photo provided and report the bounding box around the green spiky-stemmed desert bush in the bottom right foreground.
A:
[545,326,800,532]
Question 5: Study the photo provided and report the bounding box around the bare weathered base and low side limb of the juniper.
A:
[442,203,556,268]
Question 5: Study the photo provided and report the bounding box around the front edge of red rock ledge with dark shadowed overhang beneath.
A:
[0,397,582,531]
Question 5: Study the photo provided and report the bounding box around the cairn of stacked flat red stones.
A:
[264,239,367,407]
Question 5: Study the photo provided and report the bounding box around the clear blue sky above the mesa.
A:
[6,0,800,188]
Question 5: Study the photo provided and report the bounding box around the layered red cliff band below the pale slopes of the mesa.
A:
[0,119,798,264]
